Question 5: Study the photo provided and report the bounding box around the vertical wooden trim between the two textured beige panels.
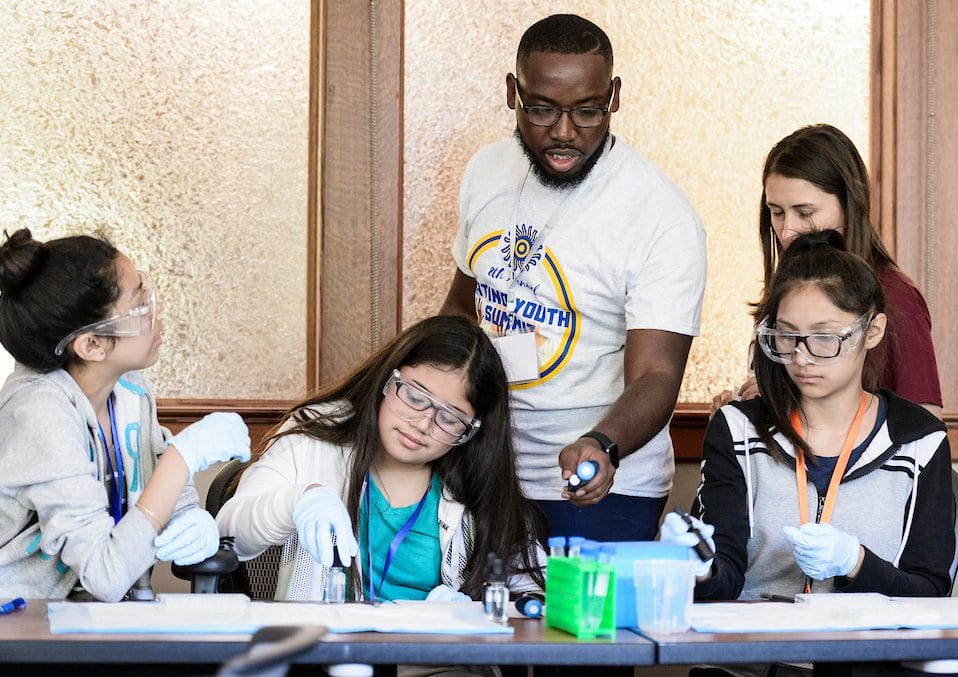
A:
[313,0,403,383]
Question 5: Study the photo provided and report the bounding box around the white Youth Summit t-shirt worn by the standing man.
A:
[452,138,705,500]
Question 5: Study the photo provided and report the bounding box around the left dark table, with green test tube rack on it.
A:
[0,600,655,674]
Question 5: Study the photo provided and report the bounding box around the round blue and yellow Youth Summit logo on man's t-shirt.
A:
[468,224,580,389]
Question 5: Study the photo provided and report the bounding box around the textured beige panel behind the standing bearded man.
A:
[403,0,870,402]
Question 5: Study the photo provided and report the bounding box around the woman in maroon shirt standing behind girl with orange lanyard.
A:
[713,125,942,417]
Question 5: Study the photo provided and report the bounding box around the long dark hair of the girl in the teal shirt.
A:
[251,316,545,598]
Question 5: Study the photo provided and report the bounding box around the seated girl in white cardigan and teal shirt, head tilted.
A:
[217,316,545,600]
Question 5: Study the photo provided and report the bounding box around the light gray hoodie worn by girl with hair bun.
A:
[0,364,197,601]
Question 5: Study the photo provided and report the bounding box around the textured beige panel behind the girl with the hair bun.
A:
[0,0,309,398]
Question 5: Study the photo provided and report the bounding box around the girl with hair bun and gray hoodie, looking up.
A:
[0,229,250,601]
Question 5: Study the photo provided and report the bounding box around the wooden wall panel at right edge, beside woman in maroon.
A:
[883,0,958,418]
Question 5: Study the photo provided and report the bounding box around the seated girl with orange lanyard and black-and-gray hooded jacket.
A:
[662,231,955,674]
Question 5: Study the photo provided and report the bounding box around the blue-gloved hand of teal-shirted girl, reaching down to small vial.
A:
[293,487,359,567]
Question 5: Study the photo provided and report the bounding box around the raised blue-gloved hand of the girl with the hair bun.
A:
[167,411,250,477]
